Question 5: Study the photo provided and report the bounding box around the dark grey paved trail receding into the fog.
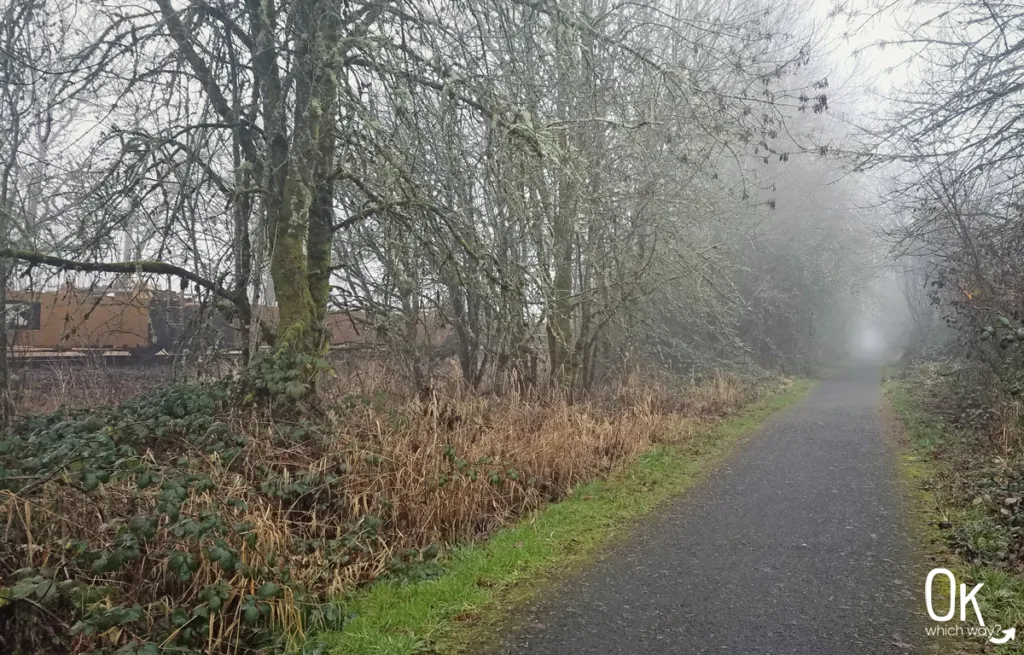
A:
[499,365,928,655]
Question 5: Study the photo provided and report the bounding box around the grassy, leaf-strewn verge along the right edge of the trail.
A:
[885,370,1024,655]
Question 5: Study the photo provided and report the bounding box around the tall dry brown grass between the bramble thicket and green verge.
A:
[311,366,761,582]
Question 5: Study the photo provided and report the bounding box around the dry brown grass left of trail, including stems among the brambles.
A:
[0,369,764,652]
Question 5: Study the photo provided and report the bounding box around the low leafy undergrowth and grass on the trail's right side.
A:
[886,363,1024,653]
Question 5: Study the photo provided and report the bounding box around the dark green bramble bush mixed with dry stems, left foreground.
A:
[0,383,354,654]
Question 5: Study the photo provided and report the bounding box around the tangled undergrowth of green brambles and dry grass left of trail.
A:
[0,359,764,655]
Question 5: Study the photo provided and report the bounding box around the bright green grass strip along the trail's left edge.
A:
[318,381,812,655]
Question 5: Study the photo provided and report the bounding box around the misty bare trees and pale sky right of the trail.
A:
[852,1,1024,397]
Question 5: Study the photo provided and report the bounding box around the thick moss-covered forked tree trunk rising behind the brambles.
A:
[250,0,341,354]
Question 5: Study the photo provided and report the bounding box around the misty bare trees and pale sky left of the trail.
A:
[0,0,897,409]
